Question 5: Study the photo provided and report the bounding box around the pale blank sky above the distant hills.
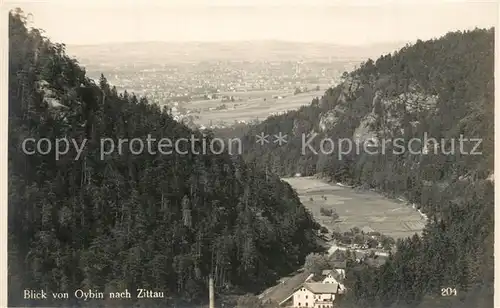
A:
[4,0,498,45]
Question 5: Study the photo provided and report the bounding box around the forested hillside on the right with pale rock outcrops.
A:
[236,29,494,308]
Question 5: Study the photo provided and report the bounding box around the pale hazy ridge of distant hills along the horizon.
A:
[67,41,405,63]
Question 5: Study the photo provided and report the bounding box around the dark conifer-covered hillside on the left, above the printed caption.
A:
[8,10,318,307]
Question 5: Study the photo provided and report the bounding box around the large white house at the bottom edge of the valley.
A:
[280,282,344,308]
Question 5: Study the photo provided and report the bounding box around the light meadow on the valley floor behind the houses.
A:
[283,177,425,239]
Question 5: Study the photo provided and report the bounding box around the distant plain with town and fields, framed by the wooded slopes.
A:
[79,61,353,129]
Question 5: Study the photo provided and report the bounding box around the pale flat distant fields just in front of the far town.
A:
[184,88,325,125]
